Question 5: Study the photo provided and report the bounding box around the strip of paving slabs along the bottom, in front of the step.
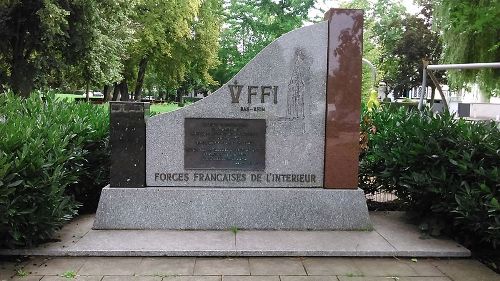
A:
[0,257,500,281]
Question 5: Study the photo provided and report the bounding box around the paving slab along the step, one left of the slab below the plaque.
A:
[136,258,195,275]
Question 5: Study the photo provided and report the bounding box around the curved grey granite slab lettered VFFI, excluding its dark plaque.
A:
[146,22,328,187]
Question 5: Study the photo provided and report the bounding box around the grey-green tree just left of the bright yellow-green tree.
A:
[67,0,134,98]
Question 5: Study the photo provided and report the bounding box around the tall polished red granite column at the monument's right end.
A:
[324,9,363,189]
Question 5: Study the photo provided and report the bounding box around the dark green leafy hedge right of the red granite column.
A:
[359,108,500,247]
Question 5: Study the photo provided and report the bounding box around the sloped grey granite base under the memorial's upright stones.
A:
[94,187,372,230]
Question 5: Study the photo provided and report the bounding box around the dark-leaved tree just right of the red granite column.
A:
[353,0,442,97]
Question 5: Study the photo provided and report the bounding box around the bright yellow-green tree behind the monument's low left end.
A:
[127,0,201,99]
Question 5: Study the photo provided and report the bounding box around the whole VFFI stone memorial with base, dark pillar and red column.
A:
[94,9,371,230]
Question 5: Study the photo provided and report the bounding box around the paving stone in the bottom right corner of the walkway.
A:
[432,259,500,281]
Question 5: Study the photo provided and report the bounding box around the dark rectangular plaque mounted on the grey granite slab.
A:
[184,118,266,171]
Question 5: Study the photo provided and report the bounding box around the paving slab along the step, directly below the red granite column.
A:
[302,258,361,275]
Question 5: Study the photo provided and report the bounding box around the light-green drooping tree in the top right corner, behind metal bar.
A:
[435,0,500,96]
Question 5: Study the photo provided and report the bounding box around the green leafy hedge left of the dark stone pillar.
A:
[0,94,109,247]
